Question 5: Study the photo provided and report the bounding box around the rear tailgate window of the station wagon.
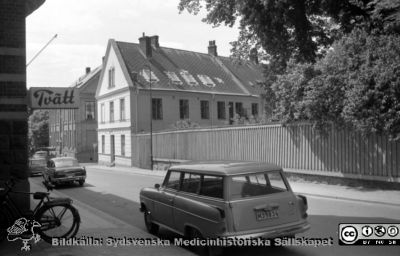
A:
[230,171,288,199]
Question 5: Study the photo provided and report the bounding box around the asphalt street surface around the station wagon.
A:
[28,167,400,256]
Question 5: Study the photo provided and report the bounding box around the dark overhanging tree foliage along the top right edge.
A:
[178,0,400,69]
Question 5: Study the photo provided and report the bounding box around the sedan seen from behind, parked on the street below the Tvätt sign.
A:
[43,157,86,186]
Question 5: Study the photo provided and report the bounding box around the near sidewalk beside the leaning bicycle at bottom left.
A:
[0,177,193,256]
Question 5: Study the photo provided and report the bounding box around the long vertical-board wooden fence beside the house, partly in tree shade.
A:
[132,124,400,181]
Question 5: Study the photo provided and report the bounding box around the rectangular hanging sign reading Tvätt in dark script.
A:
[29,87,79,109]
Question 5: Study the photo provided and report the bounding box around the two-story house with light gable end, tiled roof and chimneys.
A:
[96,35,264,166]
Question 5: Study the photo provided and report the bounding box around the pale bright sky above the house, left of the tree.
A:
[26,0,238,87]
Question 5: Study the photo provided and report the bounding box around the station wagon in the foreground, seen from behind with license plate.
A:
[140,162,310,241]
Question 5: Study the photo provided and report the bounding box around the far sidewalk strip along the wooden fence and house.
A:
[91,165,400,207]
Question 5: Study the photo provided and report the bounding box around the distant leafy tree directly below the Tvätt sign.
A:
[29,110,49,150]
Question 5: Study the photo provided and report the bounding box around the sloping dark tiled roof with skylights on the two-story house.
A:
[116,41,262,95]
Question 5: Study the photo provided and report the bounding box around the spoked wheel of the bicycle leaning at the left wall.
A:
[36,204,80,243]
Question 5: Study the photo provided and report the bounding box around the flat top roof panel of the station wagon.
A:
[170,161,282,176]
